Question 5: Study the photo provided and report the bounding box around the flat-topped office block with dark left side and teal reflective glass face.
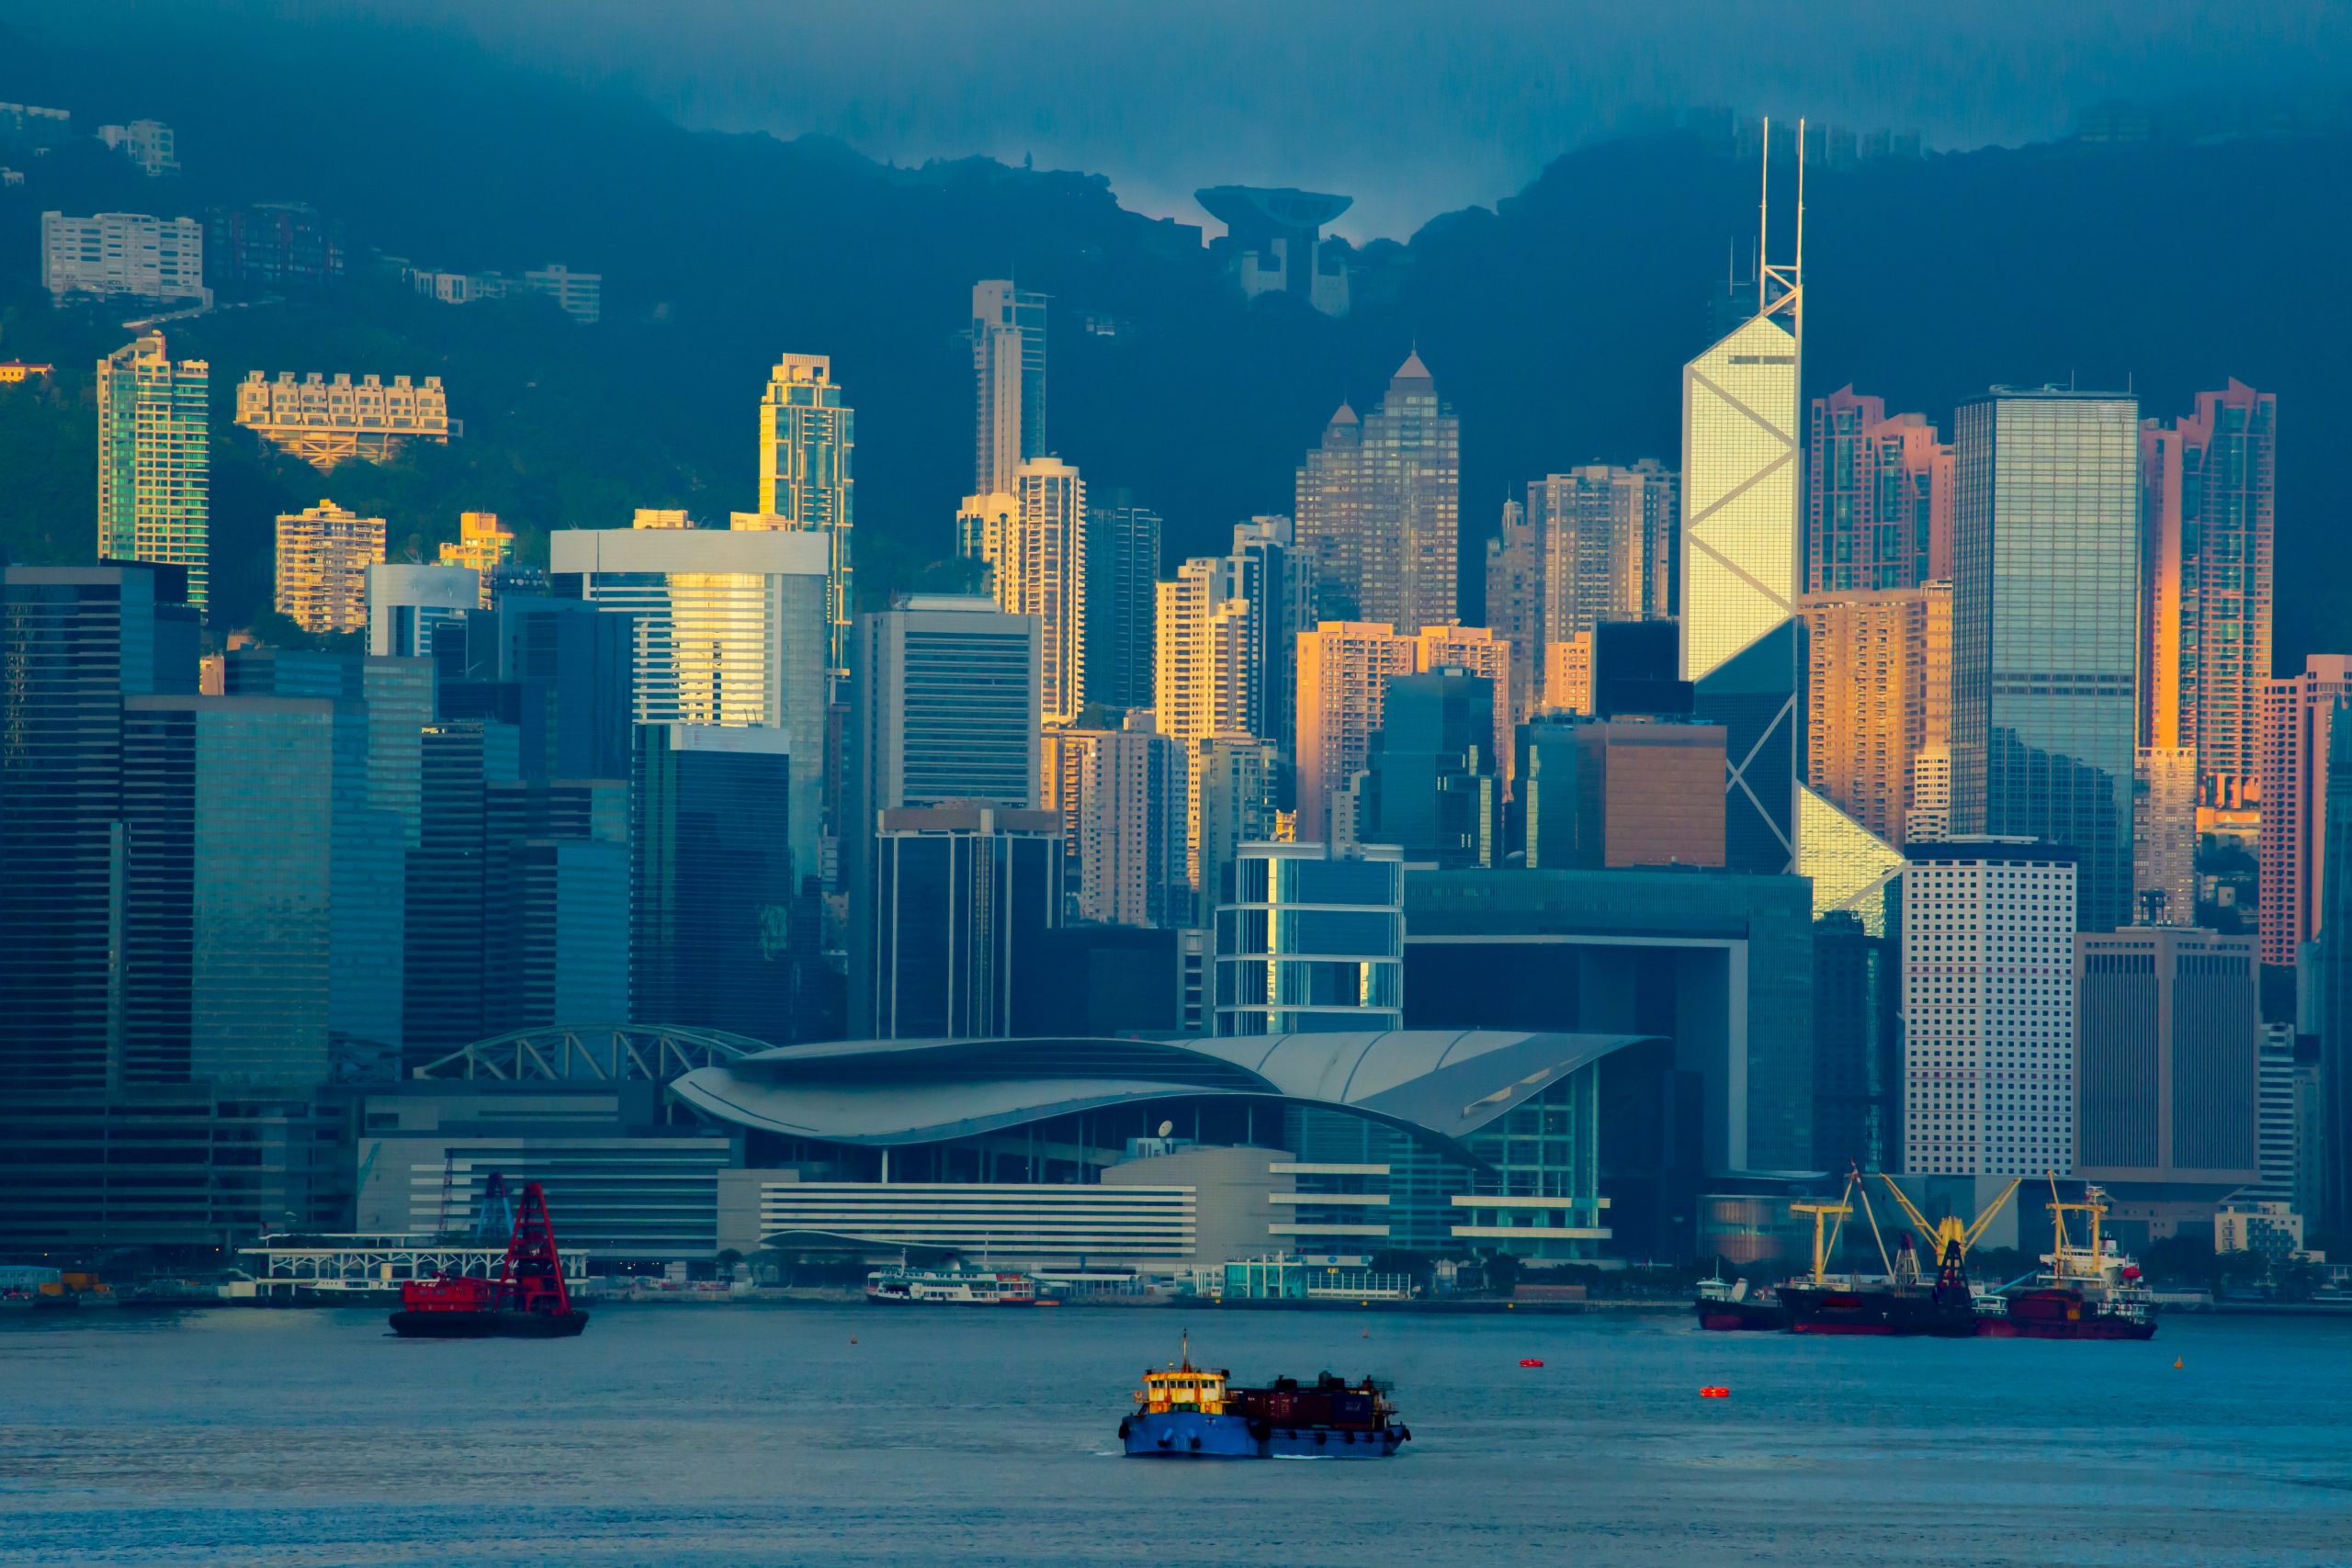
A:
[115,696,336,1089]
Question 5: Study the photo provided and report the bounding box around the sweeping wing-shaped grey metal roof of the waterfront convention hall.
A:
[671,1030,1654,1159]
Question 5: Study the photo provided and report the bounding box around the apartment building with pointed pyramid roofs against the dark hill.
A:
[1296,353,1461,632]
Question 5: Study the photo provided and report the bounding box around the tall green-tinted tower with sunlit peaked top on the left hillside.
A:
[99,332,211,611]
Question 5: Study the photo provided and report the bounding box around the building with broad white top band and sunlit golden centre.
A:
[548,526,832,874]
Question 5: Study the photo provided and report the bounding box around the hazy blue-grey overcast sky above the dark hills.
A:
[18,0,2352,237]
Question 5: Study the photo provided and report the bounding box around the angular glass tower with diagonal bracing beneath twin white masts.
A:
[1679,254,1804,872]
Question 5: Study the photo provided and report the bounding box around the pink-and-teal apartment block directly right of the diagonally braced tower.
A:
[1804,386,1954,594]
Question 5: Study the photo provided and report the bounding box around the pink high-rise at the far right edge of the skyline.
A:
[2256,653,2352,964]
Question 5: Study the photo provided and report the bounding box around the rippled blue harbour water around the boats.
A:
[0,1304,2352,1568]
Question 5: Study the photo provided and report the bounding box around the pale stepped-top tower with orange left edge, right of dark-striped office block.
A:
[1045,707,1193,926]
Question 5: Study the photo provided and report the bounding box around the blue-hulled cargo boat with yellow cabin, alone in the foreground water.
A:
[1120,1336,1414,1460]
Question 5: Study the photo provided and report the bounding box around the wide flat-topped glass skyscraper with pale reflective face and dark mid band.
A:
[1952,388,2141,931]
